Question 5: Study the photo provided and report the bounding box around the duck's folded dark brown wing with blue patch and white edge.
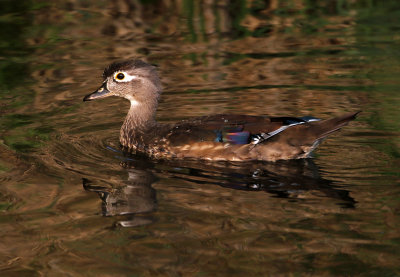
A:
[161,114,319,146]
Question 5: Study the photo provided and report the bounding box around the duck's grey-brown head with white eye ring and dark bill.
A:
[83,60,161,105]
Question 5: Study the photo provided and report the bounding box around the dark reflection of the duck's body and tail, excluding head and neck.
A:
[158,159,356,208]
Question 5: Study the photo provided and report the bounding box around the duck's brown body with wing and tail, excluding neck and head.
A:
[138,113,357,161]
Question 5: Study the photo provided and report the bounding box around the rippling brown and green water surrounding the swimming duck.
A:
[0,0,400,276]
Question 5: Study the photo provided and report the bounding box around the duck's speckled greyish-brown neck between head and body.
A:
[120,97,158,149]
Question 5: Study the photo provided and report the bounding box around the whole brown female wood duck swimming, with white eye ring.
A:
[83,60,358,161]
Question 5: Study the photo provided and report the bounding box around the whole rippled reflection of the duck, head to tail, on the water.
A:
[83,157,356,227]
